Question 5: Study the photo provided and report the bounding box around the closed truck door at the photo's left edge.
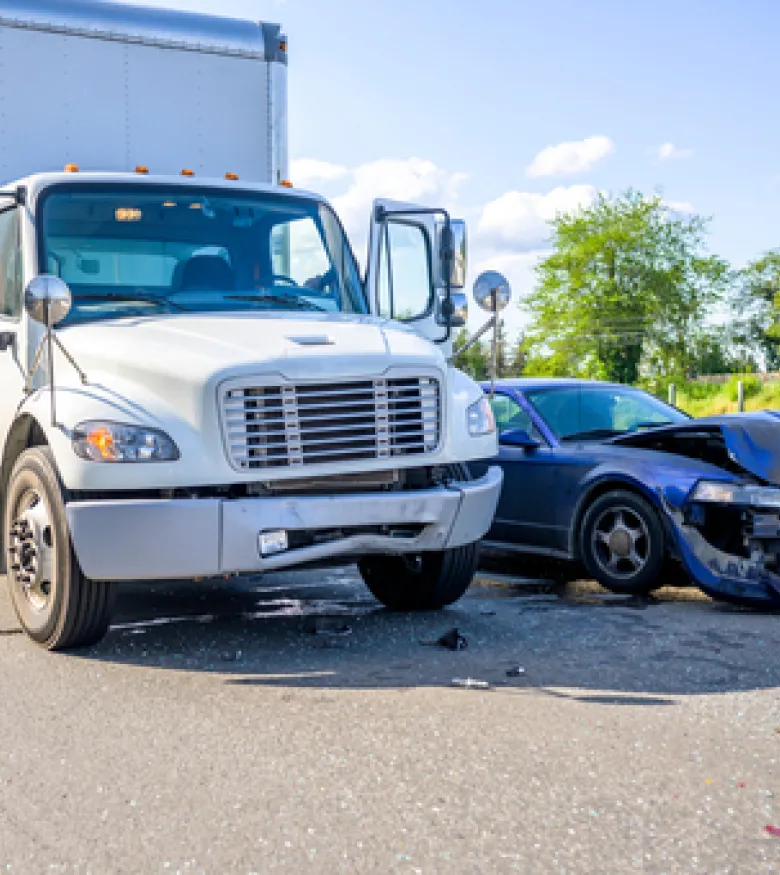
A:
[0,206,26,450]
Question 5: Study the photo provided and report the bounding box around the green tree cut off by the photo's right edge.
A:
[734,249,780,371]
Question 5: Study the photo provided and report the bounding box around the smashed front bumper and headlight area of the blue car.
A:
[665,480,780,607]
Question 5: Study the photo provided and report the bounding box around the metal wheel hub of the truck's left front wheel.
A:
[8,492,54,611]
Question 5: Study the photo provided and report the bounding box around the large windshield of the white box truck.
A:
[39,185,367,324]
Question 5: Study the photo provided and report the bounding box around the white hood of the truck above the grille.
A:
[57,313,446,429]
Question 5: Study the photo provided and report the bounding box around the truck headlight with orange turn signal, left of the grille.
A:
[73,422,180,462]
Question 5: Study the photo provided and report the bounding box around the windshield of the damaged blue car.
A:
[525,386,688,441]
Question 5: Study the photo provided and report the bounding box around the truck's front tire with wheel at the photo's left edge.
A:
[3,447,116,650]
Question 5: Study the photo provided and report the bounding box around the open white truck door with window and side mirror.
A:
[366,200,465,343]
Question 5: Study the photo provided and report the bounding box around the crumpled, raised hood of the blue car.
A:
[610,411,780,486]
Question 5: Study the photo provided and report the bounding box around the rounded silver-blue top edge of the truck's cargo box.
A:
[0,0,286,63]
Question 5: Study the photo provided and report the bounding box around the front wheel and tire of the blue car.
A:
[579,490,666,595]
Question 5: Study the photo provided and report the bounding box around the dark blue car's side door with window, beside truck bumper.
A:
[487,391,567,551]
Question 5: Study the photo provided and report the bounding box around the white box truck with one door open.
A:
[0,0,501,650]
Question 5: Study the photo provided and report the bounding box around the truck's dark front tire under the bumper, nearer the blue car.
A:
[358,465,479,611]
